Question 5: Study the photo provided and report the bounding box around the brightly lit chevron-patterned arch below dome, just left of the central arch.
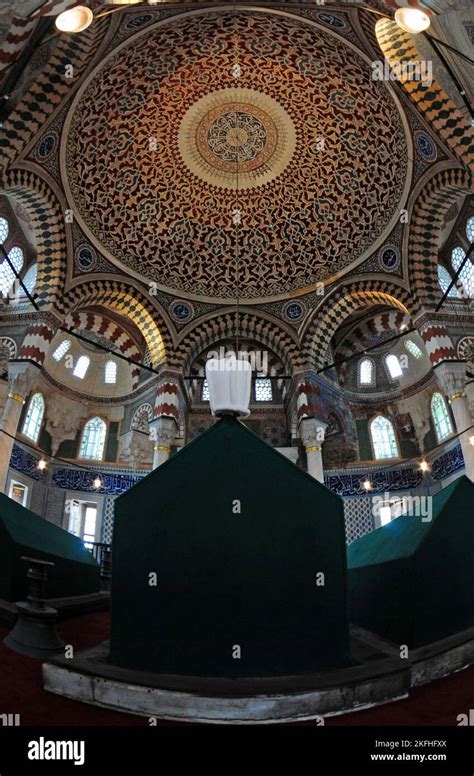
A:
[60,278,172,367]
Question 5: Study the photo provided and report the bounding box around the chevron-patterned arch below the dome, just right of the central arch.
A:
[302,280,412,369]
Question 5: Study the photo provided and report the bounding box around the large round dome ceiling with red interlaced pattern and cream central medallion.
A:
[62,11,410,303]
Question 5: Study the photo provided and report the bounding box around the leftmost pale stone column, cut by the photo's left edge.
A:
[0,361,36,493]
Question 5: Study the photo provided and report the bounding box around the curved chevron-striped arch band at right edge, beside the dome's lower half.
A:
[408,169,472,307]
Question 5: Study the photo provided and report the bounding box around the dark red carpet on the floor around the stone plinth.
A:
[0,612,474,726]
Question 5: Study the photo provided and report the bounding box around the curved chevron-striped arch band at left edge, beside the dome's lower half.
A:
[5,170,66,307]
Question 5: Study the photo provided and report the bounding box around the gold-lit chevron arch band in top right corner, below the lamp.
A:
[377,19,474,165]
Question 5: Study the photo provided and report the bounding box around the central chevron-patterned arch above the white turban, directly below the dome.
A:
[170,311,302,374]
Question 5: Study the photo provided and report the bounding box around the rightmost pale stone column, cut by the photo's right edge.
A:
[435,361,474,482]
